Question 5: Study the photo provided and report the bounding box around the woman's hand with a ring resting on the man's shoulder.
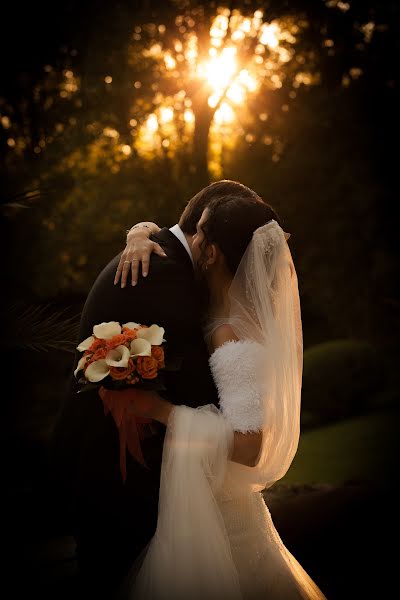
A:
[114,223,167,288]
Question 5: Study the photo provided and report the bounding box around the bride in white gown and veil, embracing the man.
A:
[108,197,326,600]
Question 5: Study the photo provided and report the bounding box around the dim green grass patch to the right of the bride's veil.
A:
[279,409,399,485]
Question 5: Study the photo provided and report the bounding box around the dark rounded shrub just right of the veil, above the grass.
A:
[302,340,384,428]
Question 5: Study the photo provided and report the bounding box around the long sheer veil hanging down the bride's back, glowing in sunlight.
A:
[227,219,303,491]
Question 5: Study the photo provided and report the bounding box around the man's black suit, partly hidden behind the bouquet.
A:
[53,229,217,597]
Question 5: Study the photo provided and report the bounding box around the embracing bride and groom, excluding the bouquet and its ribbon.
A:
[54,180,325,600]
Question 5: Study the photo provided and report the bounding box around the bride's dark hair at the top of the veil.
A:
[198,196,282,275]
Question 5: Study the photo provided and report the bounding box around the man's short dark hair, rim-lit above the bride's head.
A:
[179,179,262,235]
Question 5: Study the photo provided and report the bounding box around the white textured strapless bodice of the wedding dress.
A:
[209,340,264,433]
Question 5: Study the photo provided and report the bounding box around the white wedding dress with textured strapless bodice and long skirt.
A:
[129,340,326,600]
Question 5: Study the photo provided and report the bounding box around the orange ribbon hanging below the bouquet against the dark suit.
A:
[99,387,153,483]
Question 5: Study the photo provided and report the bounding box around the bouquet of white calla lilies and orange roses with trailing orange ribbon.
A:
[74,321,173,482]
